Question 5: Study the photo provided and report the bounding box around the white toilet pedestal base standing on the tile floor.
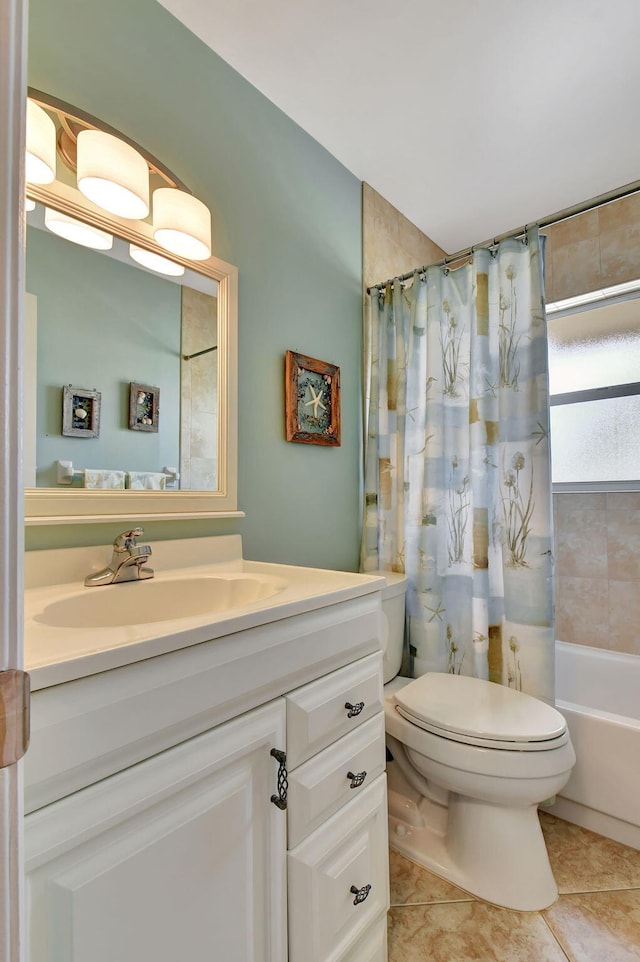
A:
[389,790,558,912]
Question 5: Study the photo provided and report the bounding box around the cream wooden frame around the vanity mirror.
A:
[25,180,244,525]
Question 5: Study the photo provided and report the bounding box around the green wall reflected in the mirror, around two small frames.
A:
[26,227,180,487]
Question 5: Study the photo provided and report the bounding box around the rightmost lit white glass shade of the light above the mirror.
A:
[153,187,211,261]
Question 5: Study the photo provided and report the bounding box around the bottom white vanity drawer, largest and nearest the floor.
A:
[287,775,389,962]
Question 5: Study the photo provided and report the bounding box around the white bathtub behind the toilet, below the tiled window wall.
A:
[547,641,640,849]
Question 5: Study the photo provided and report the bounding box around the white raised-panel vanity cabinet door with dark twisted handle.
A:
[25,699,287,962]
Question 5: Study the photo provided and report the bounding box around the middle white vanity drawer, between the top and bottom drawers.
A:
[287,712,385,848]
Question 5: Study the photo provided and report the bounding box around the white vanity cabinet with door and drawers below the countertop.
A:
[25,589,388,962]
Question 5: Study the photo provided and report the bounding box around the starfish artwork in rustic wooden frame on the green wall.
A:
[285,351,340,446]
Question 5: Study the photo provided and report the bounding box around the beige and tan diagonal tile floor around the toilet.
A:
[389,813,640,962]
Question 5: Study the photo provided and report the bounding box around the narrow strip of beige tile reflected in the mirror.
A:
[180,286,218,491]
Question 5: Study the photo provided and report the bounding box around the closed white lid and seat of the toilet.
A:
[395,672,567,750]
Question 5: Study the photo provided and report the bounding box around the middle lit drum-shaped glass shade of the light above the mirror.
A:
[78,130,149,220]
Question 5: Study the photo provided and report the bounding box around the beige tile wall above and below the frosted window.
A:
[544,195,640,655]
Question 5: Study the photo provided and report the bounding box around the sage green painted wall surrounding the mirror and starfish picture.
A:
[27,0,361,570]
